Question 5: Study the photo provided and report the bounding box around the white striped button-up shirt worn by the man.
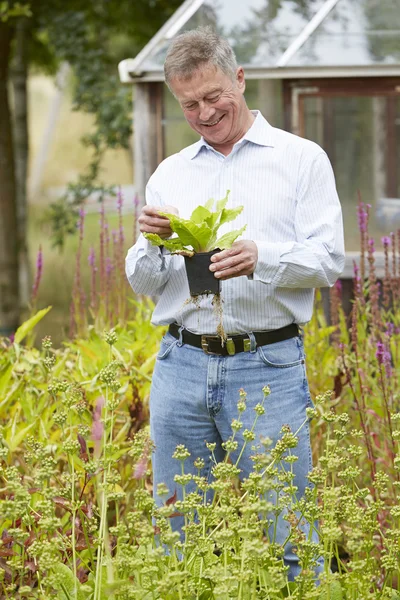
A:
[126,111,344,334]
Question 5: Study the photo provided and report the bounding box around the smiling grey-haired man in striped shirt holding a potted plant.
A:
[126,28,344,579]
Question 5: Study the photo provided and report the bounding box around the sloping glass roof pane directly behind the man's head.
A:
[143,0,324,71]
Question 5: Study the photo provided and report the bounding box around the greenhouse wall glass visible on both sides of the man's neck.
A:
[163,79,283,157]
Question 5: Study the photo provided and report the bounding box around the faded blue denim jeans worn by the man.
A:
[150,333,318,580]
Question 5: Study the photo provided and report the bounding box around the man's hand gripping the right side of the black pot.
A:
[210,240,258,281]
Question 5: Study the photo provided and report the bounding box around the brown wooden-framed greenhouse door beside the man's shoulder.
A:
[285,77,400,252]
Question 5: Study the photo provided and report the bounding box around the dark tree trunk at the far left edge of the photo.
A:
[0,21,19,335]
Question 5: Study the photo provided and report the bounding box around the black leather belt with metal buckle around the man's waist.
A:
[168,323,299,356]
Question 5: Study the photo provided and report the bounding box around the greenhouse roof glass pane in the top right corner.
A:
[288,0,400,66]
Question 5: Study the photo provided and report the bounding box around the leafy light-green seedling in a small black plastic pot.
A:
[144,190,246,297]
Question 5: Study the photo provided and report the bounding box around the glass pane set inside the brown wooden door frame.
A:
[304,96,400,251]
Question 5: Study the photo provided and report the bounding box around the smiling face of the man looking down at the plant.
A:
[170,64,254,155]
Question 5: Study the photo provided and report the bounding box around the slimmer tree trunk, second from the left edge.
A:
[11,17,32,310]
